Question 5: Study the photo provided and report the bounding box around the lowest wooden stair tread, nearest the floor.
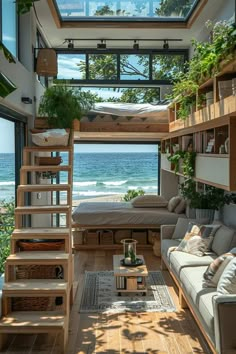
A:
[0,311,66,333]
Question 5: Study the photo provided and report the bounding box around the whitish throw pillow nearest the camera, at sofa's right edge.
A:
[217,257,236,294]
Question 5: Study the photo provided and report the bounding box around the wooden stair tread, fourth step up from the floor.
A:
[11,227,70,240]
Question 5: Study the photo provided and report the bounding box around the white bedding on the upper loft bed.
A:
[90,102,168,117]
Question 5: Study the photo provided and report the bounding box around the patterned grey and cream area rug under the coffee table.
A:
[79,271,176,313]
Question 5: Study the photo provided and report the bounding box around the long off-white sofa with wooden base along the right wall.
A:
[161,219,236,354]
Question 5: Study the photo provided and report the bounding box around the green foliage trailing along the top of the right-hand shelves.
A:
[171,21,236,119]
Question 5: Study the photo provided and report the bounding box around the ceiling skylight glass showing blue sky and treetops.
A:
[55,0,201,21]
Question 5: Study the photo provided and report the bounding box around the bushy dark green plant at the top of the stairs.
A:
[39,84,94,129]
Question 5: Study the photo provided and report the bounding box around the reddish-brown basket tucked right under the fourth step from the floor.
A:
[17,239,65,251]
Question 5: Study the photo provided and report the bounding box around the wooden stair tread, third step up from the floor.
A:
[6,251,70,265]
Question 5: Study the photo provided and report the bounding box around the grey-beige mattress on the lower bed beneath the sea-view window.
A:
[72,202,186,228]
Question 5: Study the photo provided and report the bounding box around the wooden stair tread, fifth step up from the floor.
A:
[15,205,70,215]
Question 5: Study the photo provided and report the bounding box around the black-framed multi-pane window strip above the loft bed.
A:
[57,49,188,85]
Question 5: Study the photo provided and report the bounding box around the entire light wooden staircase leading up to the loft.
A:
[0,138,74,353]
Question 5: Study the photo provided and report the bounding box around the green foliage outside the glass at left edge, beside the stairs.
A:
[0,200,15,273]
